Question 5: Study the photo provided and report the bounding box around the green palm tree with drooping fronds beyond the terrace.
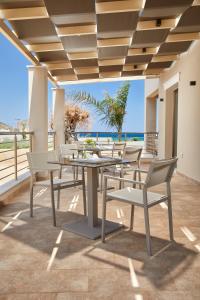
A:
[73,82,130,140]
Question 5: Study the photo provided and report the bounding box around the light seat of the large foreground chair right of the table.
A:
[107,187,166,206]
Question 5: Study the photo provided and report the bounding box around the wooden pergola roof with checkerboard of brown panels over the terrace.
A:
[0,0,200,85]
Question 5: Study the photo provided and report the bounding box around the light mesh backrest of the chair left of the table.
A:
[27,151,59,174]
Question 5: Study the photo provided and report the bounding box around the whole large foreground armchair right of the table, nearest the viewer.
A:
[102,158,177,255]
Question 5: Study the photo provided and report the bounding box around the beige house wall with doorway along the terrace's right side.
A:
[159,41,200,181]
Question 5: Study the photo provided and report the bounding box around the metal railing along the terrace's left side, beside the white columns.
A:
[0,132,55,185]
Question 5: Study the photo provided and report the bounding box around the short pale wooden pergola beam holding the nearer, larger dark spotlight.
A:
[137,19,177,30]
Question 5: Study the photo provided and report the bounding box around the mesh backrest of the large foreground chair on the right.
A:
[146,158,177,187]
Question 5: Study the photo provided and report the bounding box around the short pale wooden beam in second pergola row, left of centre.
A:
[57,24,97,36]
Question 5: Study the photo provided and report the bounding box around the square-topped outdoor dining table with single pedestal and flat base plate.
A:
[49,158,130,239]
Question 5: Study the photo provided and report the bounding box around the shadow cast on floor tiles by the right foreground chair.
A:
[84,231,198,288]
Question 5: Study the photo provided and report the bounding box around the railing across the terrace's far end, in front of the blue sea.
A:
[76,131,158,156]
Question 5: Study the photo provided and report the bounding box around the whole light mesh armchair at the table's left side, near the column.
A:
[27,151,86,226]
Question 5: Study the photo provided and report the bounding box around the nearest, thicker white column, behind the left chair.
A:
[28,66,48,152]
